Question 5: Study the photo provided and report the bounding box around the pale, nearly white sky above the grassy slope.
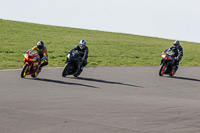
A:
[0,0,200,43]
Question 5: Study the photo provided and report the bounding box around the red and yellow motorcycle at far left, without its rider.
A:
[21,50,46,78]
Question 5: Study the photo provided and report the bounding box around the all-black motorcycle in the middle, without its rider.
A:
[62,51,82,77]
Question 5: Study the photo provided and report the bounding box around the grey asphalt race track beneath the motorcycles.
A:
[0,67,200,133]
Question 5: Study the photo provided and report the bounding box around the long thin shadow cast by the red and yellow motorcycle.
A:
[27,78,98,88]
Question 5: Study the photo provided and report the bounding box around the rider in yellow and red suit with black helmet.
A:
[31,41,48,72]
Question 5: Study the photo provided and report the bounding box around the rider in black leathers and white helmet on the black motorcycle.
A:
[70,40,89,76]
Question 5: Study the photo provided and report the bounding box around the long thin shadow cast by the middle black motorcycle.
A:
[68,77,144,88]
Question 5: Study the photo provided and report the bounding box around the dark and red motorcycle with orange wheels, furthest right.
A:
[159,51,177,76]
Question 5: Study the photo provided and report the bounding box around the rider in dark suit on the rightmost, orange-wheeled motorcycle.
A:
[164,41,183,70]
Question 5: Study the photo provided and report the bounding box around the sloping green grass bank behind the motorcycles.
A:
[0,19,200,69]
